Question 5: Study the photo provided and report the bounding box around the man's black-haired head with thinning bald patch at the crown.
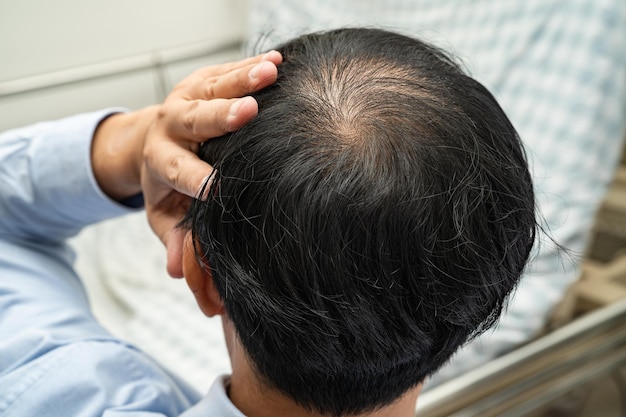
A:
[188,29,535,415]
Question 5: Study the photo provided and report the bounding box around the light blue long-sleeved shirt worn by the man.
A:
[0,110,243,417]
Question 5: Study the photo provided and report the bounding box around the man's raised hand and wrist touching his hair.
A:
[92,51,282,277]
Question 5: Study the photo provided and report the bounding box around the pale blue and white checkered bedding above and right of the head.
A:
[248,0,626,386]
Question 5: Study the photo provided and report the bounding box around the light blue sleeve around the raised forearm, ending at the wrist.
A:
[0,109,138,242]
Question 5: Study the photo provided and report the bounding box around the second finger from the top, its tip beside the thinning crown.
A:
[180,61,278,100]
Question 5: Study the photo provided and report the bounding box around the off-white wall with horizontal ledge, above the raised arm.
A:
[0,0,247,130]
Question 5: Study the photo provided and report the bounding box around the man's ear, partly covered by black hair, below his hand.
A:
[183,231,224,317]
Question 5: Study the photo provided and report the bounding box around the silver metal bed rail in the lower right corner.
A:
[416,300,626,417]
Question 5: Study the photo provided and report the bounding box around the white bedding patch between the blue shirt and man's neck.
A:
[71,212,230,393]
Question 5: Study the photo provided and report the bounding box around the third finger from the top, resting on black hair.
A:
[164,97,258,142]
